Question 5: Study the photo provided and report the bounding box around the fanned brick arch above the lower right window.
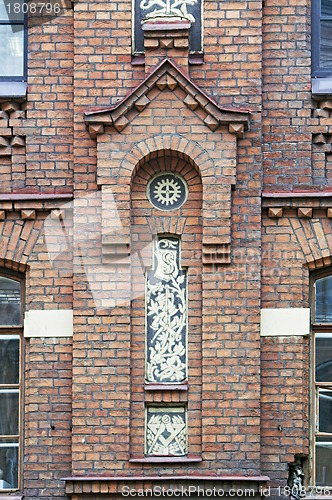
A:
[290,219,332,271]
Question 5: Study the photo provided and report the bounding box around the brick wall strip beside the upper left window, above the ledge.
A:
[25,9,73,193]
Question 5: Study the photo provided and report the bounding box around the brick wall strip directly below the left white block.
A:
[23,339,72,499]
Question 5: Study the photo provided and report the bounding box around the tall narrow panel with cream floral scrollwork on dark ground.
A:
[145,237,188,383]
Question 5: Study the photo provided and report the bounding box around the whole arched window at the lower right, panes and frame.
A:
[313,271,332,486]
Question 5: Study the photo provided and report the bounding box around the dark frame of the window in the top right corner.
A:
[311,0,332,78]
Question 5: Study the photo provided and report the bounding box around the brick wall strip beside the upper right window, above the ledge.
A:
[262,0,312,191]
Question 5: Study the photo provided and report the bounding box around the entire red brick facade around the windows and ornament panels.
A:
[0,0,332,500]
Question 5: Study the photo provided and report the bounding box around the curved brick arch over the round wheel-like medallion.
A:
[120,134,214,184]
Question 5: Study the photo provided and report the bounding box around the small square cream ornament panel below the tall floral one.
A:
[145,406,188,456]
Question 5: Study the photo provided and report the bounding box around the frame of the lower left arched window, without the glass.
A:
[0,268,25,495]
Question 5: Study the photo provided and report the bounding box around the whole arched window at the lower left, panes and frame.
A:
[0,273,23,490]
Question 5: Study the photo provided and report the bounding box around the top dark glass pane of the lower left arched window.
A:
[0,276,21,326]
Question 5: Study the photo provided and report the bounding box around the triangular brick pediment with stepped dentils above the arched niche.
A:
[84,59,250,137]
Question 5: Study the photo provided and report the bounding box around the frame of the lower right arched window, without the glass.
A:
[310,268,332,488]
